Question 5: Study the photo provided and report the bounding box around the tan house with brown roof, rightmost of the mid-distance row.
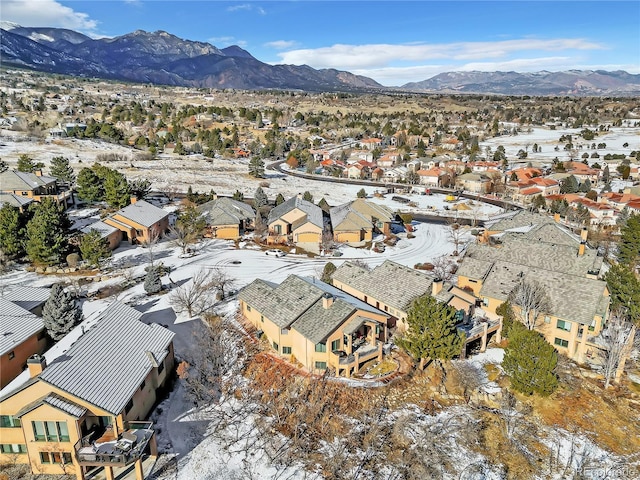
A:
[329,198,395,246]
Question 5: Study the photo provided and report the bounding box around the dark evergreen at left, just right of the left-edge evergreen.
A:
[25,198,70,265]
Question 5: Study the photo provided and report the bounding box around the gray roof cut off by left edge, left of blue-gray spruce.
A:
[0,297,44,355]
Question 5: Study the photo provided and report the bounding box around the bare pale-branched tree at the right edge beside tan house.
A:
[597,312,636,388]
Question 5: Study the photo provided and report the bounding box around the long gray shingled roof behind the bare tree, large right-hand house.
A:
[480,262,608,325]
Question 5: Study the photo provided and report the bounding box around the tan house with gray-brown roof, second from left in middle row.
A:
[198,197,256,240]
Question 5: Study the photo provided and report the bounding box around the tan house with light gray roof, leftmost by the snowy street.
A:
[103,198,169,244]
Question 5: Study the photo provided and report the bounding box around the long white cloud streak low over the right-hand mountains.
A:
[278,38,605,70]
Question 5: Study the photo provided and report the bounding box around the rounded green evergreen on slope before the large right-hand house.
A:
[502,323,558,397]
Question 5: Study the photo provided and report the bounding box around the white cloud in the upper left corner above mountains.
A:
[2,0,98,35]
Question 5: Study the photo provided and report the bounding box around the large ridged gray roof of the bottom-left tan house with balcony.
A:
[39,302,174,415]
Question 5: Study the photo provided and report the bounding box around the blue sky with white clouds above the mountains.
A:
[0,0,640,86]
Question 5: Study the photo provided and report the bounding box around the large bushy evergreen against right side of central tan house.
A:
[396,295,464,368]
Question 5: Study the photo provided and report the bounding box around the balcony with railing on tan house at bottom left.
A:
[75,422,154,467]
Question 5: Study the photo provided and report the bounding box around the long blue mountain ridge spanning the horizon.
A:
[0,21,640,96]
